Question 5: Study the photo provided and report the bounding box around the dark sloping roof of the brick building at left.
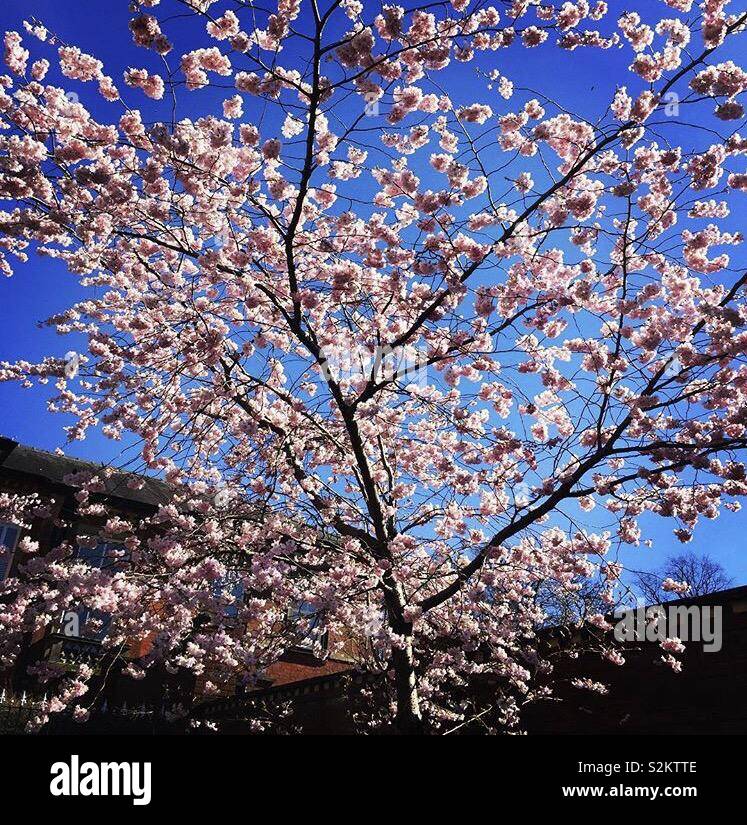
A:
[0,436,171,507]
